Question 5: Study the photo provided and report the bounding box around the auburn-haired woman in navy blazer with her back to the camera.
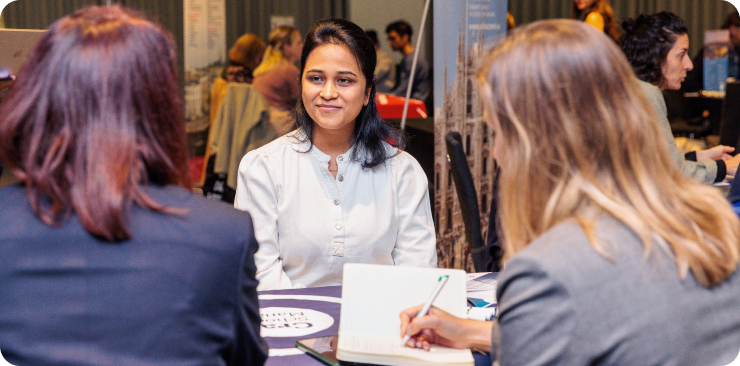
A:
[0,6,267,365]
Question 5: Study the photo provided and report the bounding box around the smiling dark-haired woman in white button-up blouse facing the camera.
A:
[235,19,437,289]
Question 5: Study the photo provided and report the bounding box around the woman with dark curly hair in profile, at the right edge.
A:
[619,12,740,184]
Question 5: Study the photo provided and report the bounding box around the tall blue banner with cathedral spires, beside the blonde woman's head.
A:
[433,0,507,272]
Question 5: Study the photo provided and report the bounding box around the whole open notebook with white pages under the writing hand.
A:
[337,263,474,366]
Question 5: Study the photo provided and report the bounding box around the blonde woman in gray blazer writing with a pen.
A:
[401,19,740,365]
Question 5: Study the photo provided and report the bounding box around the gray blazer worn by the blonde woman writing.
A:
[491,218,740,366]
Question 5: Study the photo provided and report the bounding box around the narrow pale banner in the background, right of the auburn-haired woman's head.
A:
[183,0,227,156]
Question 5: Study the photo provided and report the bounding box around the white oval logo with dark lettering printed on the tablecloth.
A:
[260,307,334,337]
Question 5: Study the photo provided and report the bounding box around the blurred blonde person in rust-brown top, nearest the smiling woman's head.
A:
[253,25,303,135]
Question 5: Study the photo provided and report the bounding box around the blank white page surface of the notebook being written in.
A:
[339,263,467,338]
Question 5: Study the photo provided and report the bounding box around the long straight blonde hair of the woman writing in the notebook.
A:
[478,19,740,286]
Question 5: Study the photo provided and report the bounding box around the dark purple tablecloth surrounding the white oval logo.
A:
[259,286,491,366]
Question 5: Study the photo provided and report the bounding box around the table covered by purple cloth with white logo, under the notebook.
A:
[258,286,491,366]
